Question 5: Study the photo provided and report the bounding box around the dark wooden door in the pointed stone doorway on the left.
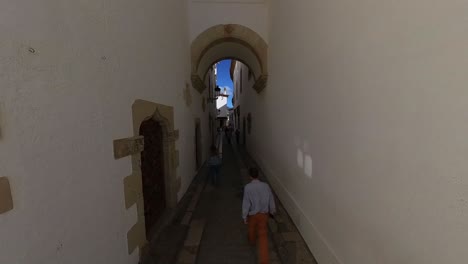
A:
[140,119,166,240]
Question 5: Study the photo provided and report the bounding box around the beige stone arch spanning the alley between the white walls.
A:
[191,24,268,93]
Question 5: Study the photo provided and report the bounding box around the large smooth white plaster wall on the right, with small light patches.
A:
[248,0,468,264]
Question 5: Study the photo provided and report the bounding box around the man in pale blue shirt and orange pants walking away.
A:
[242,168,276,264]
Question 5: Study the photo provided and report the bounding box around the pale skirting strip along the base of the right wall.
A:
[249,151,343,264]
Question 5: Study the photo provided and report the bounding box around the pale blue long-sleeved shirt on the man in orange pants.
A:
[242,180,276,220]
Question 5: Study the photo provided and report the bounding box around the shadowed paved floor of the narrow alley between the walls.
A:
[143,140,316,264]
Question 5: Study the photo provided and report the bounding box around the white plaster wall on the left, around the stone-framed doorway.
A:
[0,0,207,264]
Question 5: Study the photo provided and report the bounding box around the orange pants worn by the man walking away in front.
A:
[248,214,269,264]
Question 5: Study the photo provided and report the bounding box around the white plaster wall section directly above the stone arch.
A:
[186,0,269,42]
